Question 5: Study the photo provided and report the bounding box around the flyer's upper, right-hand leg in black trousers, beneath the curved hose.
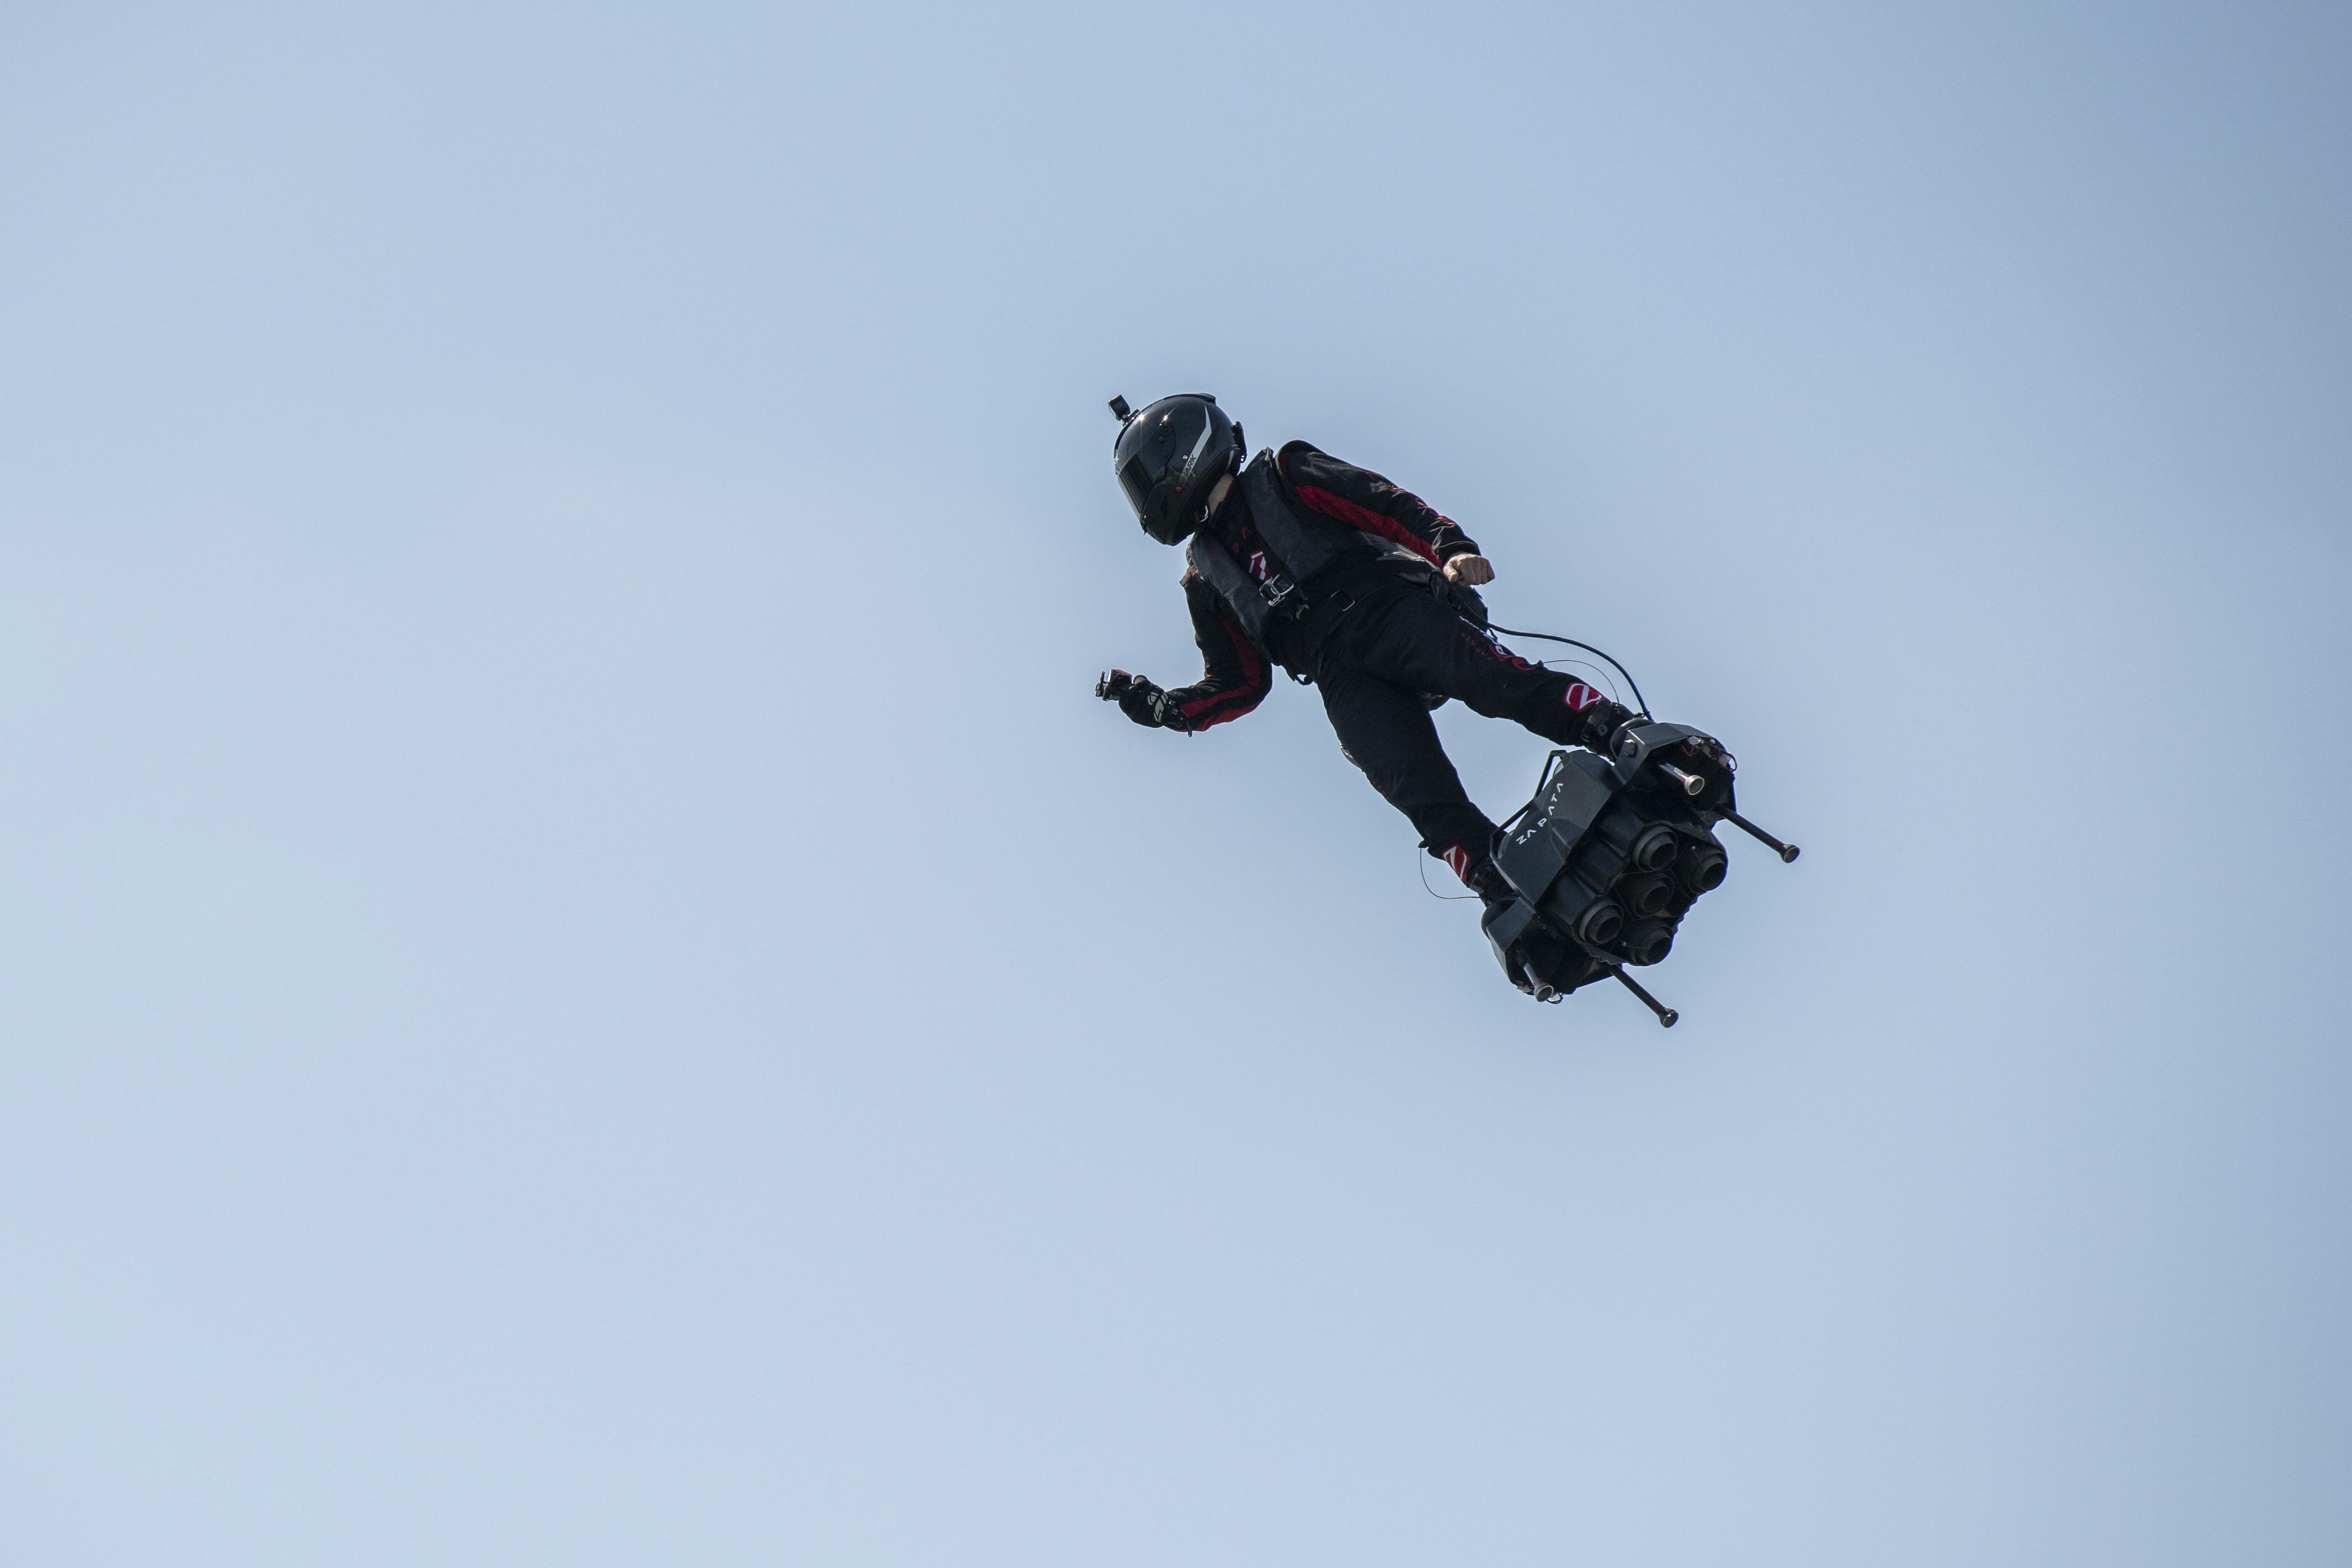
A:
[1347,590,1625,745]
